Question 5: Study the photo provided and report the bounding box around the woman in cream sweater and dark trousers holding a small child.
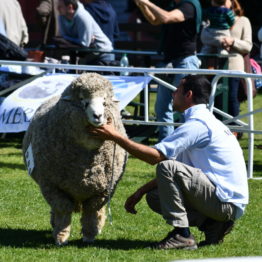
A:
[221,0,252,124]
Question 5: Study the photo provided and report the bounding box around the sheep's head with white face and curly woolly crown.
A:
[63,73,113,126]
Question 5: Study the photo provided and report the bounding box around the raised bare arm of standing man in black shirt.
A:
[135,0,185,25]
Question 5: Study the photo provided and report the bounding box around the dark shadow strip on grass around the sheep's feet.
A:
[0,228,150,250]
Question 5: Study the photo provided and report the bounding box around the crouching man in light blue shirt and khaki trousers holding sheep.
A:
[89,75,248,249]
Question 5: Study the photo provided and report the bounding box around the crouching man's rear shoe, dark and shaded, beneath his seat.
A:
[198,219,234,247]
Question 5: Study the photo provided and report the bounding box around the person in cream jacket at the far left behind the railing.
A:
[0,0,29,47]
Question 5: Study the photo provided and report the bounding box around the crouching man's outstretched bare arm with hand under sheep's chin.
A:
[88,124,166,165]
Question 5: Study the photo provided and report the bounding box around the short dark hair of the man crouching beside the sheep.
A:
[183,75,211,105]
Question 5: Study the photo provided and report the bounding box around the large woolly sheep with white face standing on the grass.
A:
[23,73,127,245]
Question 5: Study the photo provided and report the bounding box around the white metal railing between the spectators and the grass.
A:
[0,60,262,178]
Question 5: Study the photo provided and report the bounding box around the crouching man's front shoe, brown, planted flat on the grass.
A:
[150,229,197,250]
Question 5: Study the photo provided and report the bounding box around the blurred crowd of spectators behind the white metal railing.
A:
[0,0,262,140]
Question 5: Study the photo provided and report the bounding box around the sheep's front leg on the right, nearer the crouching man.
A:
[81,198,106,243]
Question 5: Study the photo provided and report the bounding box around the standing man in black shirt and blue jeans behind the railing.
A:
[135,0,202,140]
